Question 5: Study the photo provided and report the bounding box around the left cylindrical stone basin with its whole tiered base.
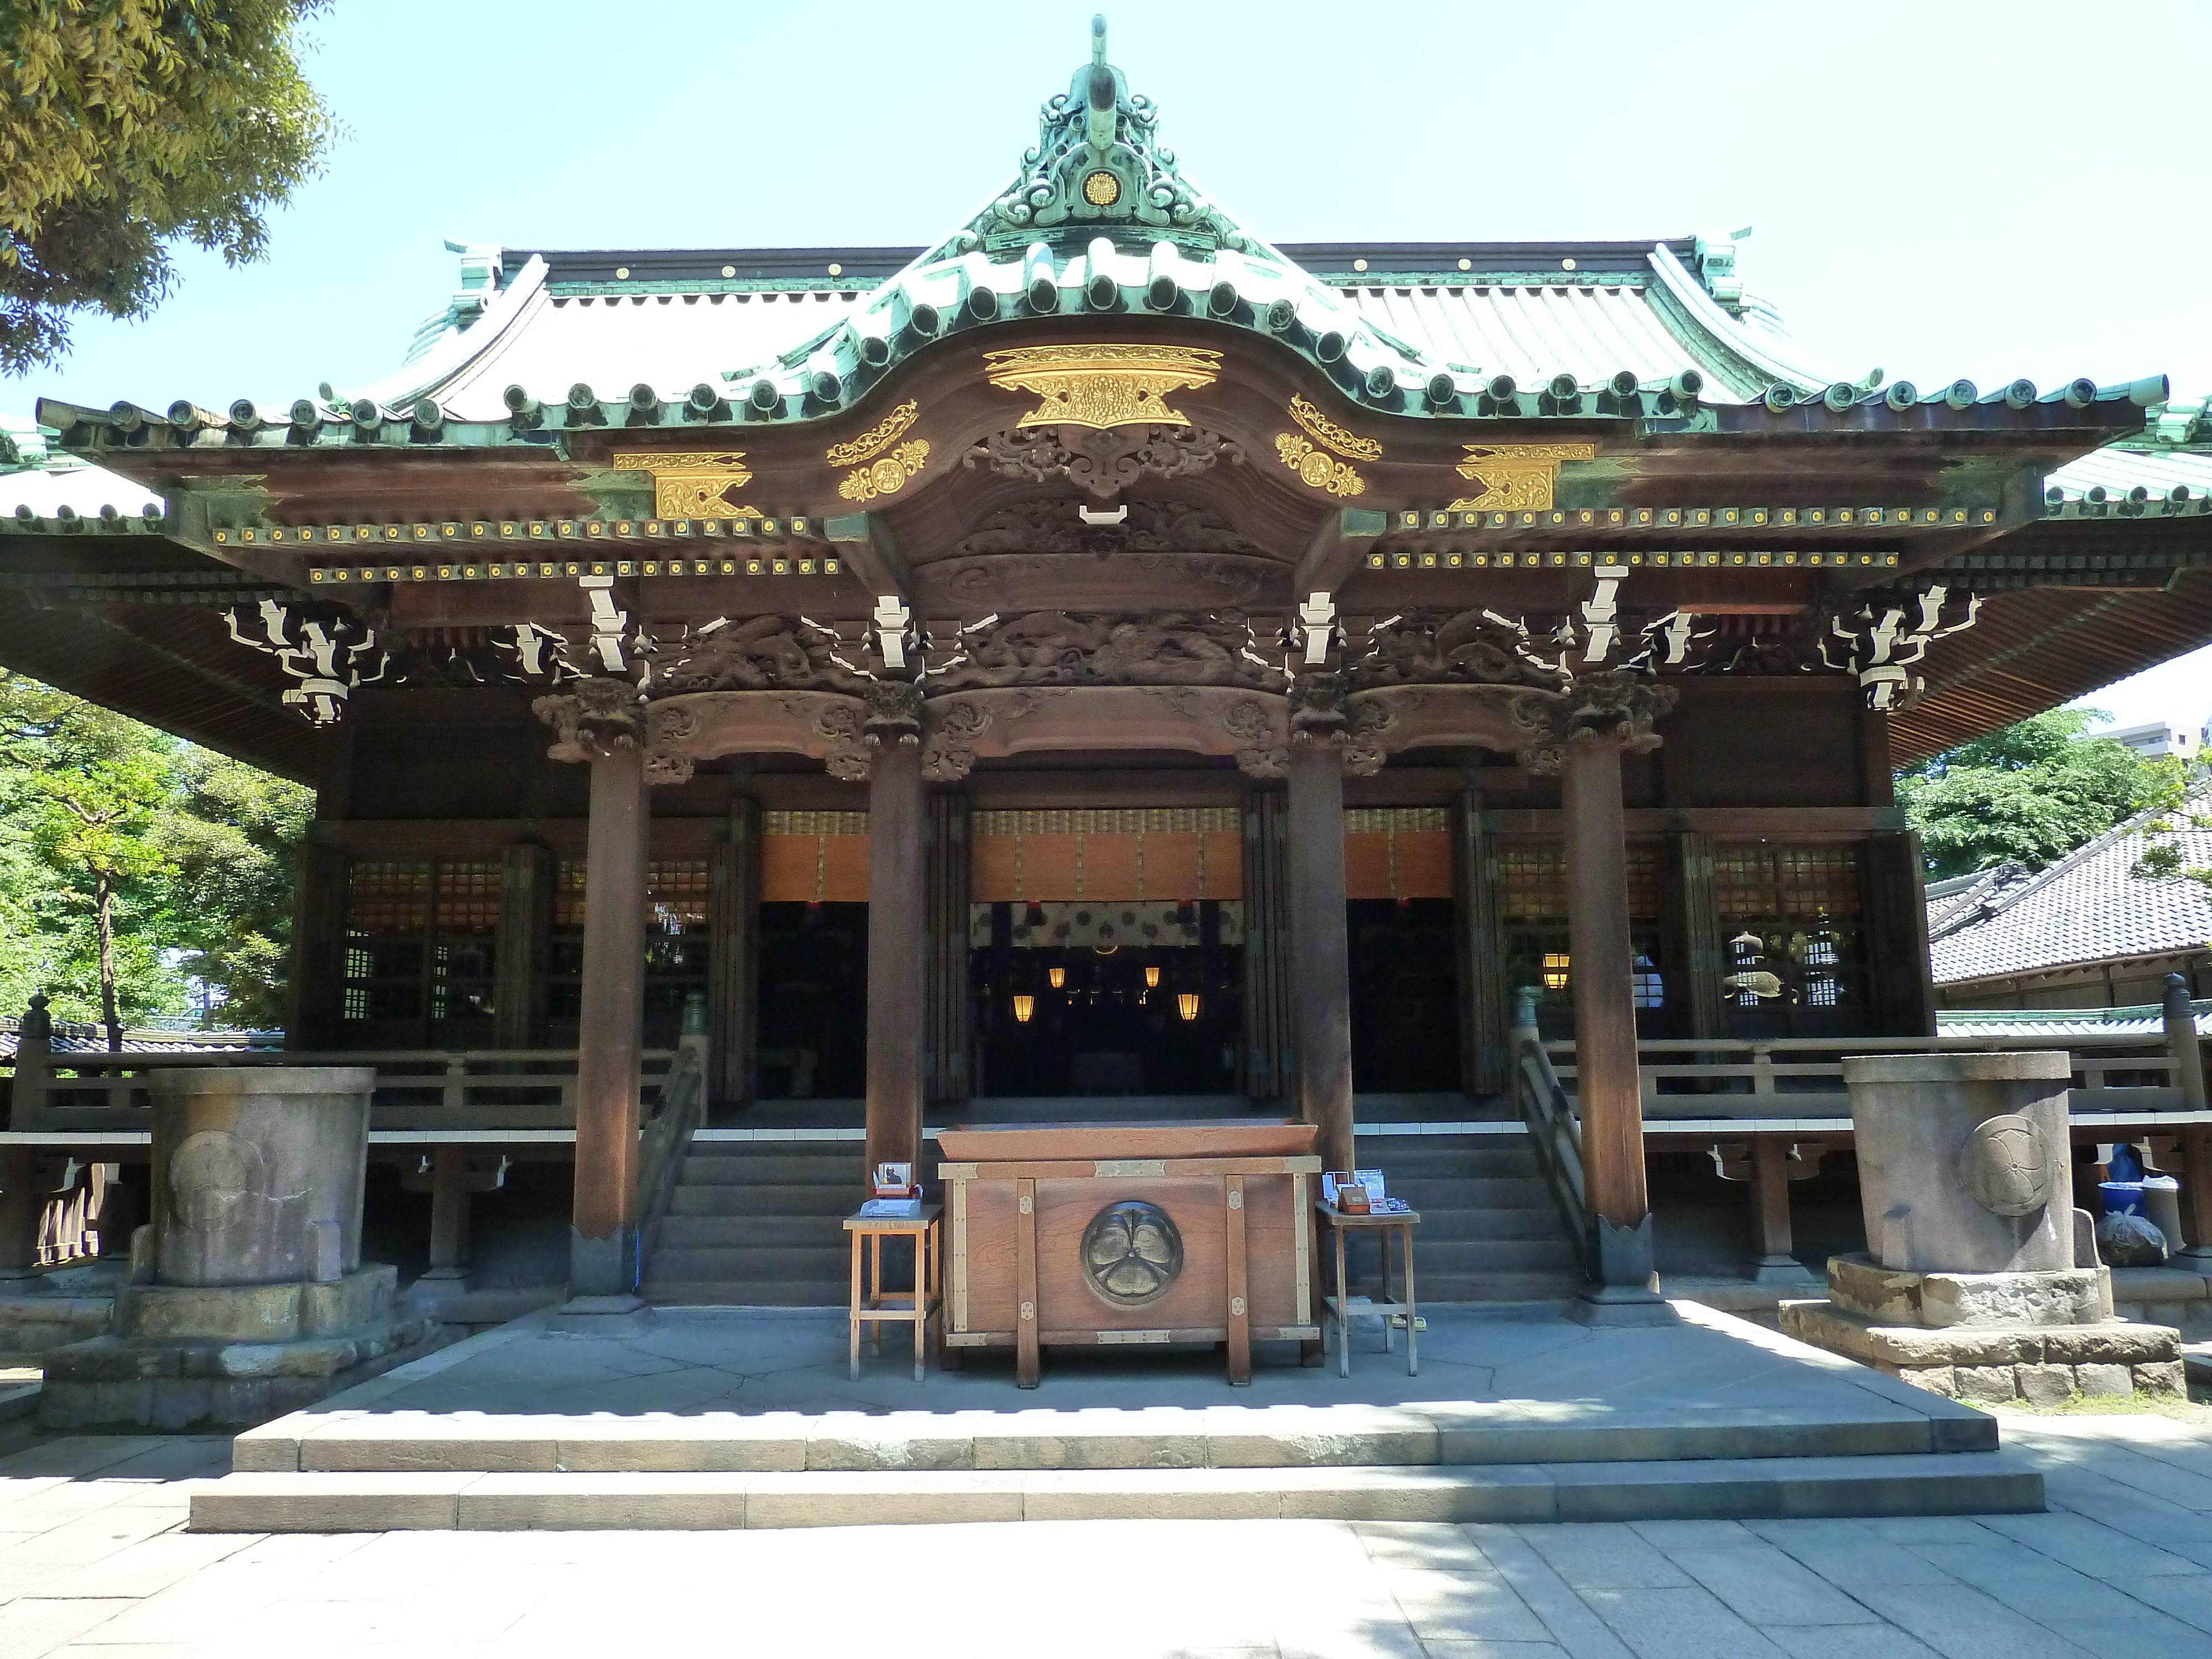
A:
[40,1066,440,1431]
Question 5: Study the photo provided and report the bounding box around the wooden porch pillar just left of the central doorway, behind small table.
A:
[867,741,927,1170]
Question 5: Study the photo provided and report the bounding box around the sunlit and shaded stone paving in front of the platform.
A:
[0,1416,2212,1659]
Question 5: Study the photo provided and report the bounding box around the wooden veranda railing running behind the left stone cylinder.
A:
[9,1042,677,1133]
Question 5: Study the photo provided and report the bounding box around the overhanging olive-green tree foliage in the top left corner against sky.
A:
[0,0,336,374]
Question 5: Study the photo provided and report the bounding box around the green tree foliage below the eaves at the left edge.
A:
[0,675,314,1026]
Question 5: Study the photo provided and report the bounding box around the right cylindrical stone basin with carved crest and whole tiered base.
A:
[1778,1051,2183,1405]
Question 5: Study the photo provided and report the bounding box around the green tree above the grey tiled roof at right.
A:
[1898,708,2166,876]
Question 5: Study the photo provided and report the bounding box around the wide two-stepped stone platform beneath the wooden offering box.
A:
[192,1305,2044,1533]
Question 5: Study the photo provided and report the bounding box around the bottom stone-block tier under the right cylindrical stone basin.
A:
[1781,1301,2185,1405]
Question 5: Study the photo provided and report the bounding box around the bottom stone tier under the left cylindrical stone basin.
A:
[38,1318,453,1433]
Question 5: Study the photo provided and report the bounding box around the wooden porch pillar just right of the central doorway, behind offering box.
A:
[1287,741,1354,1170]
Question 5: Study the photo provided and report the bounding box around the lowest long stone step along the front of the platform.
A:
[190,1451,2044,1533]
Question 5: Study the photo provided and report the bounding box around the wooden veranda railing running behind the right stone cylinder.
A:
[1542,1031,2188,1124]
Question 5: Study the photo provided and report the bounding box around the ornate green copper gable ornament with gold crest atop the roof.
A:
[933,15,1252,259]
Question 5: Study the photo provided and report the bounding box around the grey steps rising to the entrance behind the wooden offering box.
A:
[646,1135,1579,1307]
